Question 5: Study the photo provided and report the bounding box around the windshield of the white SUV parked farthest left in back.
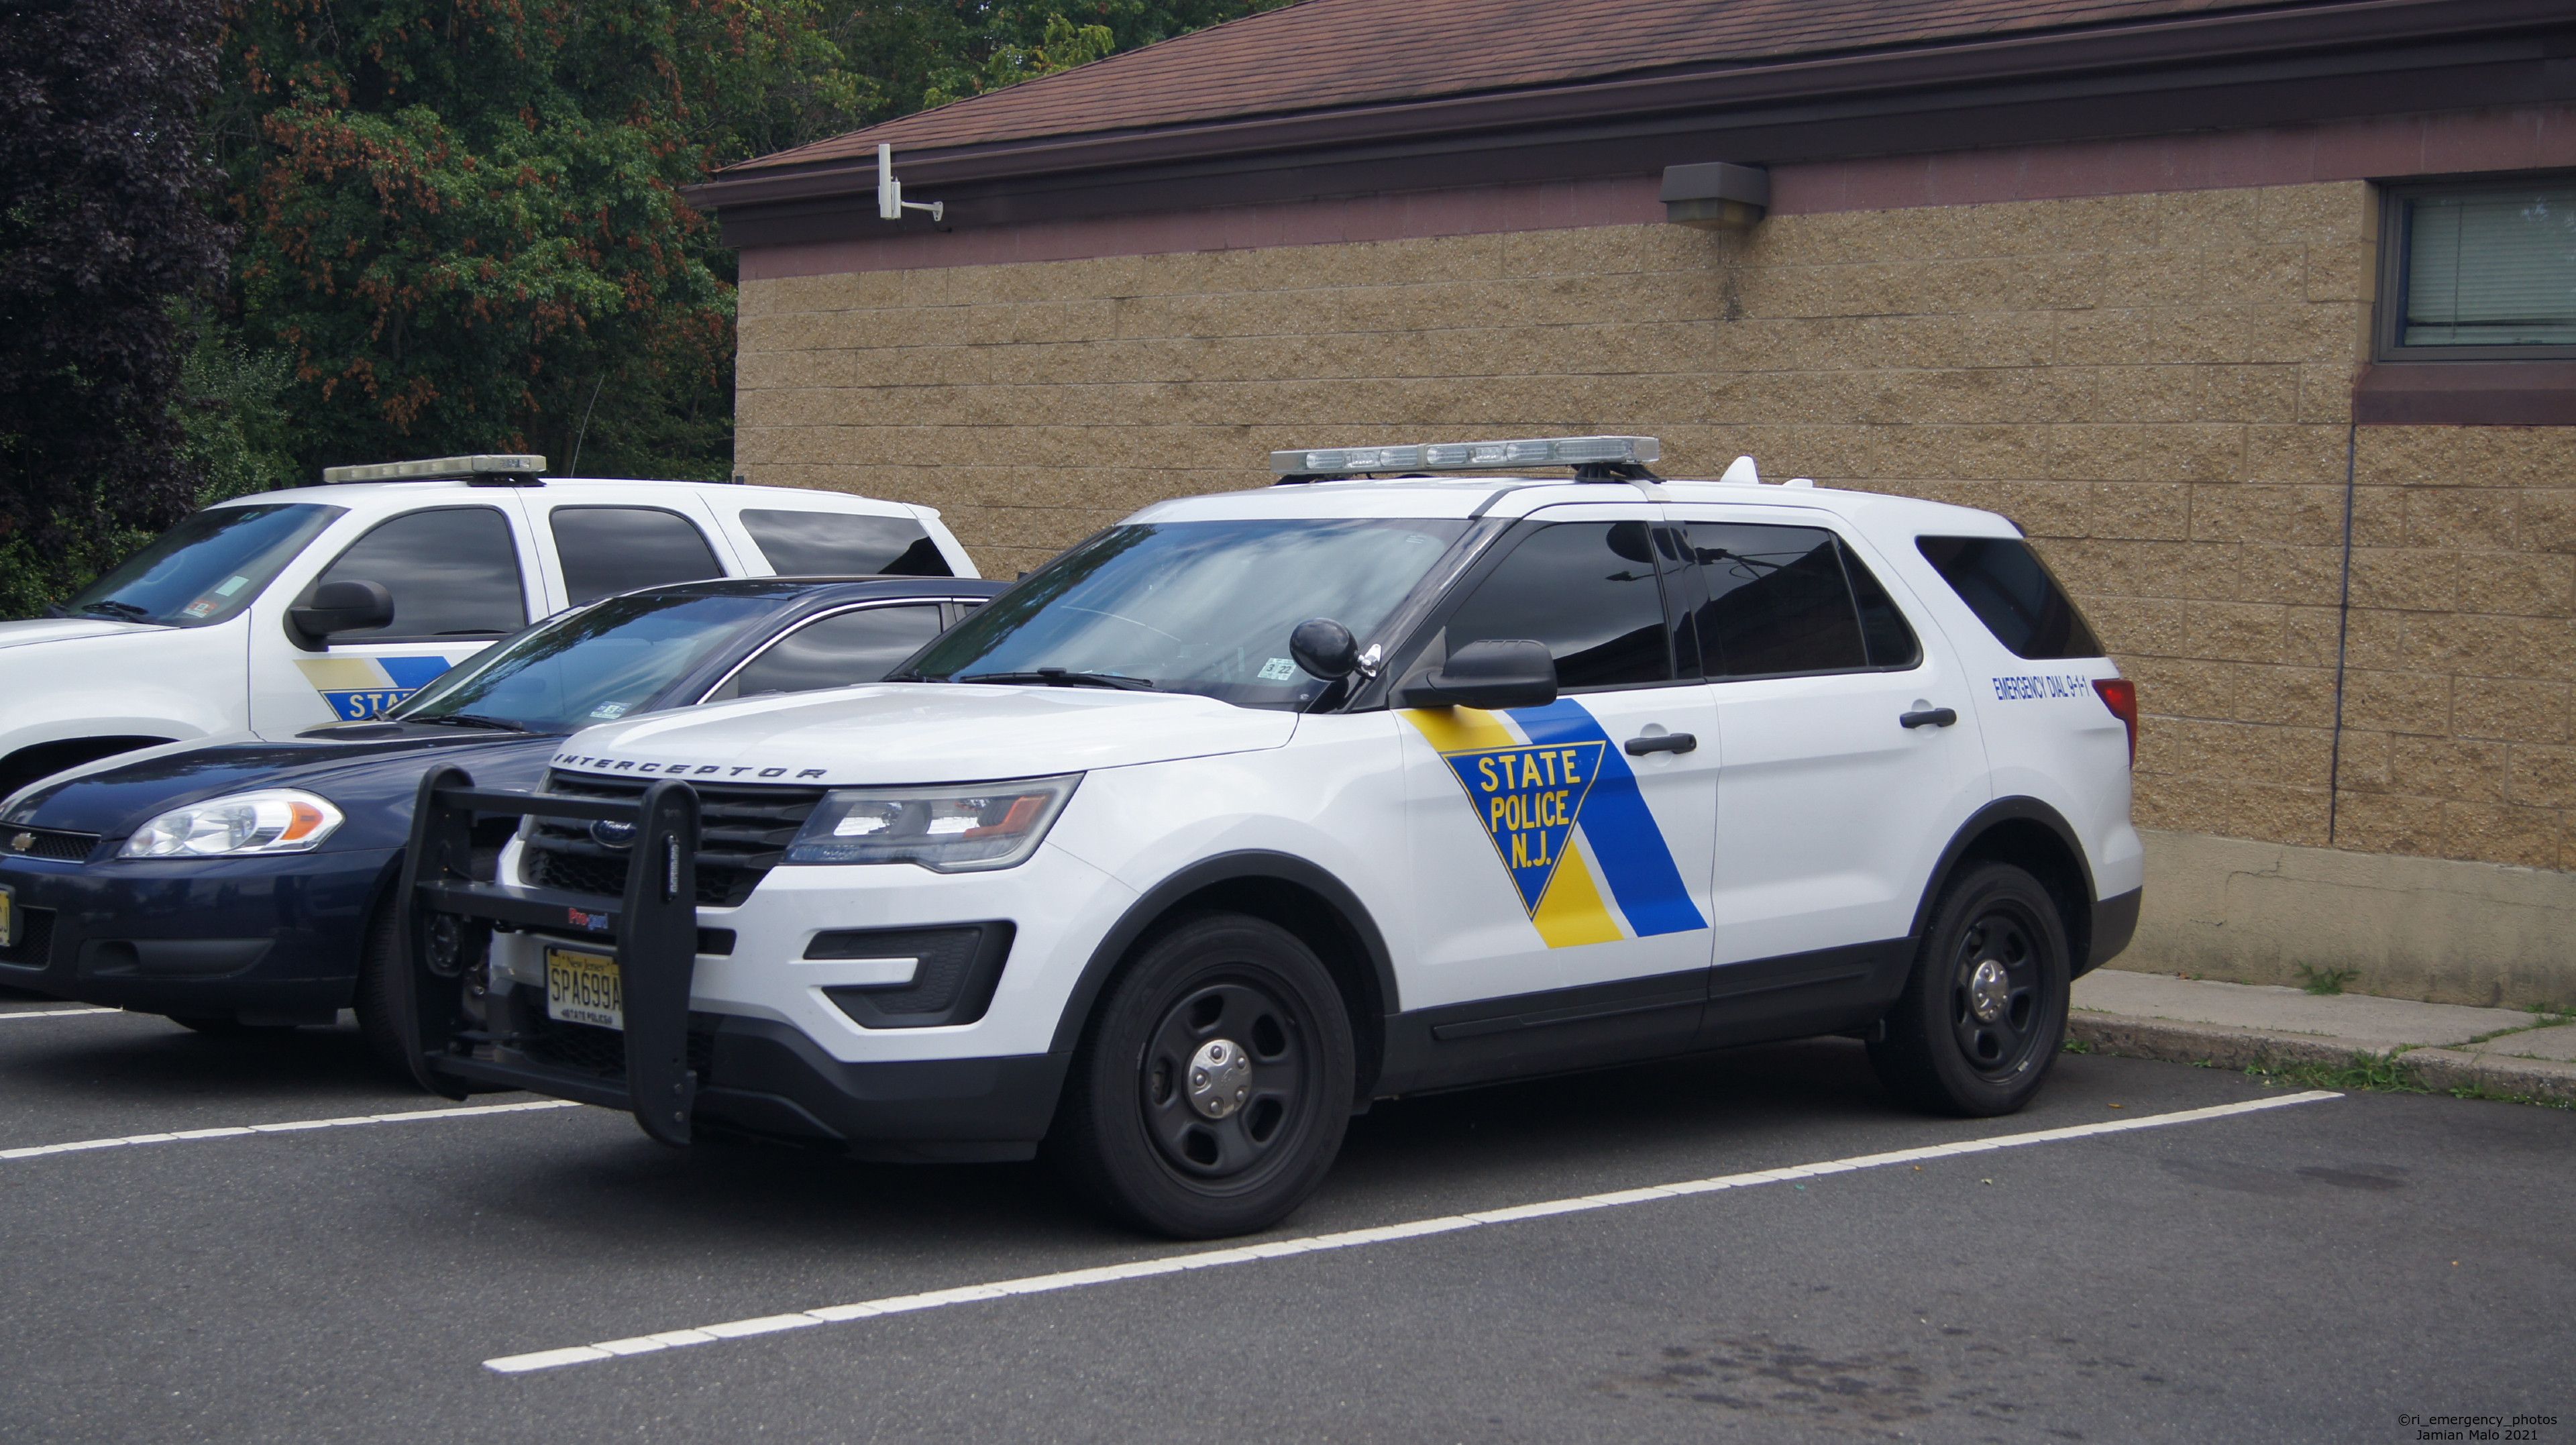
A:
[62,502,347,626]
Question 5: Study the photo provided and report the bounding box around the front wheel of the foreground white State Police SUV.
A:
[1046,914,1355,1239]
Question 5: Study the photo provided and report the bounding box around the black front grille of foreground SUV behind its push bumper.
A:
[521,770,824,909]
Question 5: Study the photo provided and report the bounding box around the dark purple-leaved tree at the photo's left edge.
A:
[0,0,227,616]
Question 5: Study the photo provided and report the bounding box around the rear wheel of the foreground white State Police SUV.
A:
[1870,863,2071,1118]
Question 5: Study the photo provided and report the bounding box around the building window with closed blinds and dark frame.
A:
[2380,178,2576,361]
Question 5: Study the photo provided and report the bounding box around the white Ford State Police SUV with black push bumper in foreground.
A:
[407,438,2141,1236]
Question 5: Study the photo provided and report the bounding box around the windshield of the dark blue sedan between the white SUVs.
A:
[386,592,778,731]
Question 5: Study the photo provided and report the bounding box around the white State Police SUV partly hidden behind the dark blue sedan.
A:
[0,456,976,798]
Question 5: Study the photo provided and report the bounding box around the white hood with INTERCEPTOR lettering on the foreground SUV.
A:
[554,682,1296,786]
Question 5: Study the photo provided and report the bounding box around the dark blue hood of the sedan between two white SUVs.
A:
[8,727,561,847]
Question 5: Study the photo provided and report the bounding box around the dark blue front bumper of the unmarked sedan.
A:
[0,847,396,1022]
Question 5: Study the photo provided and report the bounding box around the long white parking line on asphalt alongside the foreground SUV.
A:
[484,1089,2342,1375]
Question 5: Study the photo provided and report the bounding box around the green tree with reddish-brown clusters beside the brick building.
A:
[219,0,873,476]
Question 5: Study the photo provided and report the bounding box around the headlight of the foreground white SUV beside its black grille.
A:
[786,773,1082,873]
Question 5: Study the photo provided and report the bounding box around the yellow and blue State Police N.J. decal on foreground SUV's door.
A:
[1399,698,1708,948]
